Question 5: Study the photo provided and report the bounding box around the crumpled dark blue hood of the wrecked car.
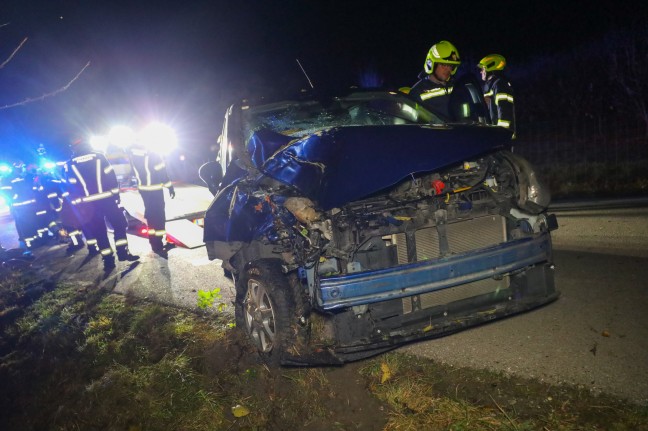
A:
[253,125,510,210]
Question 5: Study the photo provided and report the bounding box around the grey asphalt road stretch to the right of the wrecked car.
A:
[402,208,648,405]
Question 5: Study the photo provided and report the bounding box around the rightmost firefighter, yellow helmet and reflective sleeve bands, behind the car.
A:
[477,54,516,138]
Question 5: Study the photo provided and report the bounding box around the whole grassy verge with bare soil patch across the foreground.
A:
[0,269,648,431]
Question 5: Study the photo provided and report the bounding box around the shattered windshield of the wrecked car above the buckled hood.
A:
[242,92,443,138]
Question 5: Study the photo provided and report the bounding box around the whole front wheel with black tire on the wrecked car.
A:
[235,260,304,366]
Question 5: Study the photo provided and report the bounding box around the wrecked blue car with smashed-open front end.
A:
[204,80,558,365]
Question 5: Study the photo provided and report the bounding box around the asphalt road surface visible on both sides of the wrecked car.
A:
[5,198,648,404]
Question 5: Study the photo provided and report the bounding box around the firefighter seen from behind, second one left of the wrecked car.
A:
[65,139,139,271]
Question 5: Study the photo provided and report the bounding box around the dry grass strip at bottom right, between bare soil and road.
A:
[362,353,648,431]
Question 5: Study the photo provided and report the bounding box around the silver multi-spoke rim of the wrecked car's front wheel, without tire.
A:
[243,280,276,353]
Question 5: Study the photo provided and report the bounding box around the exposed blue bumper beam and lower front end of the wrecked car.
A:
[282,232,560,365]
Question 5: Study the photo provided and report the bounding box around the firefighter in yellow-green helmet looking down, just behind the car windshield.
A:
[409,40,461,120]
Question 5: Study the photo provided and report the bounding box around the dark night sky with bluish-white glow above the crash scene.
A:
[0,0,646,164]
